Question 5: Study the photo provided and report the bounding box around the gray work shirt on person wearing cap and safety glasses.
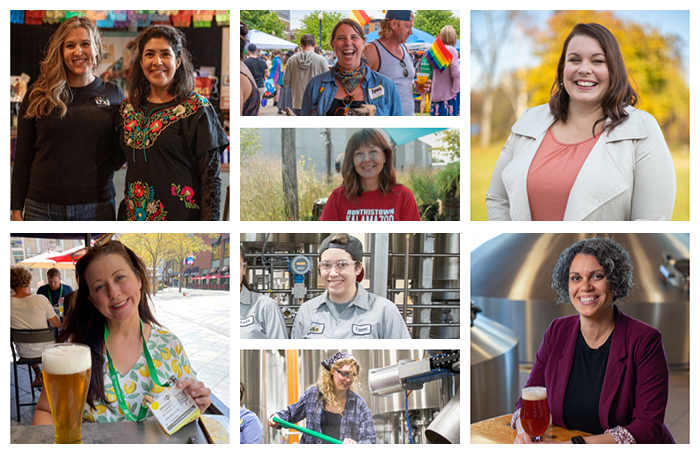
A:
[292,284,411,339]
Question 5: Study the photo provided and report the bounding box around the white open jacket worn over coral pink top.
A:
[486,104,676,221]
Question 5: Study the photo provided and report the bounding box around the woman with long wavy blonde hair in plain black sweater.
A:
[10,17,124,221]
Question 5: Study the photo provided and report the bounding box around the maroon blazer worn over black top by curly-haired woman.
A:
[515,306,675,444]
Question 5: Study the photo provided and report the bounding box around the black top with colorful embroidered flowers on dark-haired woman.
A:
[120,93,228,221]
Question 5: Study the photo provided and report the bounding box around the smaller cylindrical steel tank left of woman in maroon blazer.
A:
[470,314,520,422]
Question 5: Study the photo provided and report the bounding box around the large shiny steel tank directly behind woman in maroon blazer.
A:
[471,233,690,367]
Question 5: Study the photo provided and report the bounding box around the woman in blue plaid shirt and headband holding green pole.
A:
[268,352,377,444]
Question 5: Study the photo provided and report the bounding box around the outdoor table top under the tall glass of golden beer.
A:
[10,420,207,444]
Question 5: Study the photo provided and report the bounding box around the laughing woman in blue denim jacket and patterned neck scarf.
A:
[301,19,403,116]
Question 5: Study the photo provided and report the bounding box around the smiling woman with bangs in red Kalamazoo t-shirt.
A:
[321,129,420,221]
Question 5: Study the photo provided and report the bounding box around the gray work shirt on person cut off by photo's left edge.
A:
[240,286,287,339]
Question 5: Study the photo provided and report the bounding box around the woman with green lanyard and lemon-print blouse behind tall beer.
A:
[32,237,211,425]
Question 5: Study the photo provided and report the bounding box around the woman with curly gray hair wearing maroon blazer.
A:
[512,237,674,444]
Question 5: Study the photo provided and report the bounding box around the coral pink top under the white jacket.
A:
[527,127,600,221]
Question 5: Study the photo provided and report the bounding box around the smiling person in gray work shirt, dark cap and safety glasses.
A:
[292,234,411,339]
